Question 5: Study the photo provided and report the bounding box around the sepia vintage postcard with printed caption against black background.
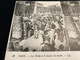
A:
[5,1,80,60]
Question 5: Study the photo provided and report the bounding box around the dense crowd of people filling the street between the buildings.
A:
[8,13,65,51]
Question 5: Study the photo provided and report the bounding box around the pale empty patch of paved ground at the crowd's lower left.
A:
[20,36,43,51]
